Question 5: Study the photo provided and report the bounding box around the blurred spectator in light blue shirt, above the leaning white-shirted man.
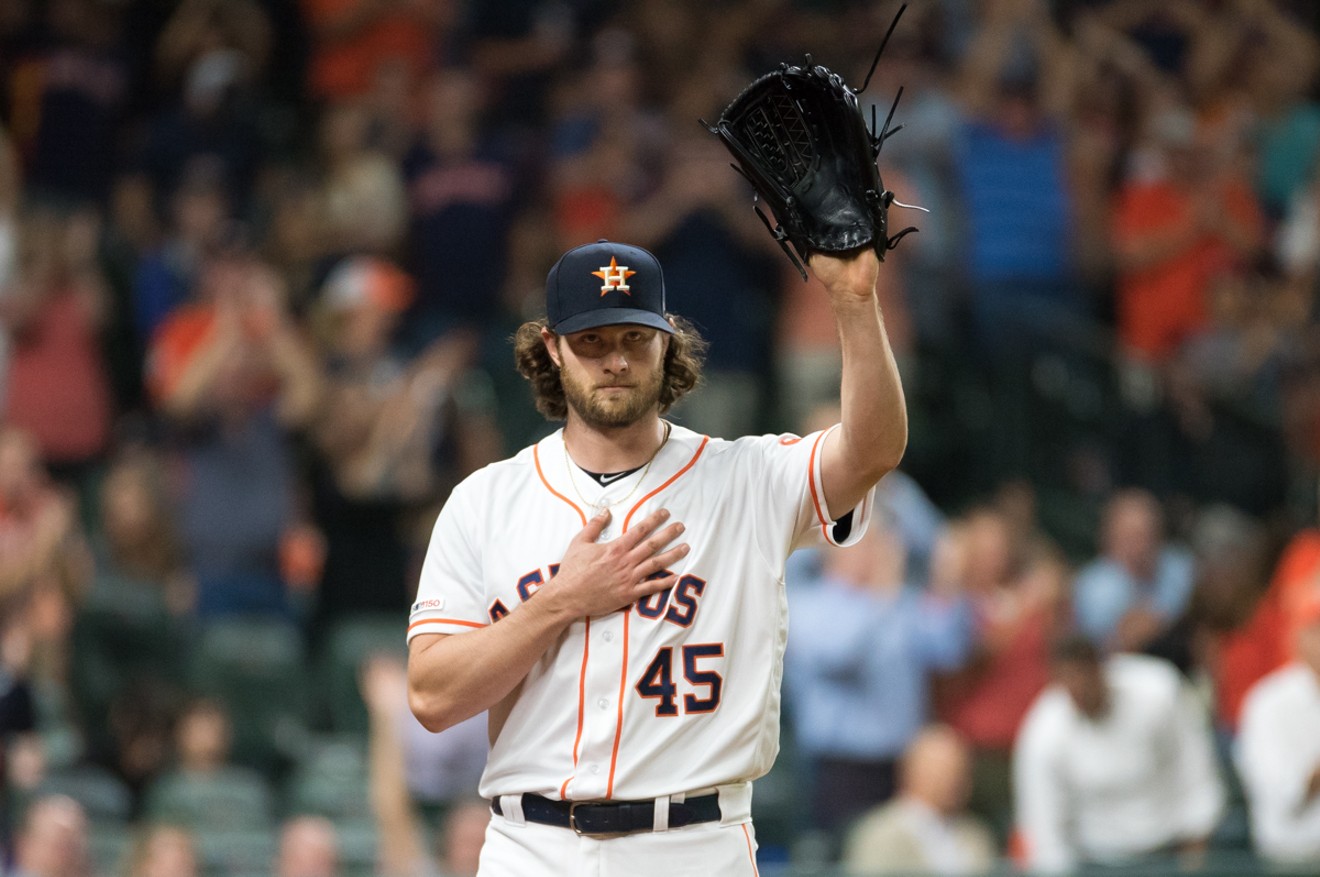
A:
[1073,490,1192,651]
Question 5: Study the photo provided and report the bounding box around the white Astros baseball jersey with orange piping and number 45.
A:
[408,427,873,800]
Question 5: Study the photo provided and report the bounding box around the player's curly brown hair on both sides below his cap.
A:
[513,314,708,420]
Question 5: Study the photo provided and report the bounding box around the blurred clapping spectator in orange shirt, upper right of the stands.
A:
[1114,108,1265,362]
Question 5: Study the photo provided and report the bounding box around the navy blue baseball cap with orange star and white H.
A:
[545,240,673,335]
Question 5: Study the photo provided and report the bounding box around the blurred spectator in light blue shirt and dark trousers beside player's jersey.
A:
[784,526,972,832]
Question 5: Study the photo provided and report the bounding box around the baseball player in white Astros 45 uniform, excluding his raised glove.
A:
[408,240,907,877]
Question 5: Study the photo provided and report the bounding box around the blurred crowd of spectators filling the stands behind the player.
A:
[0,0,1320,877]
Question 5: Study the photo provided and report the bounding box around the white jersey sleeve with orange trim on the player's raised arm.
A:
[748,424,875,553]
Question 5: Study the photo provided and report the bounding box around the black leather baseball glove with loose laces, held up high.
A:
[706,7,916,279]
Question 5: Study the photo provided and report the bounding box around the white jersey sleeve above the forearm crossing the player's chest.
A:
[408,483,490,641]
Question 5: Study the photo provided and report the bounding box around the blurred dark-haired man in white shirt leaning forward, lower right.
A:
[1014,635,1225,873]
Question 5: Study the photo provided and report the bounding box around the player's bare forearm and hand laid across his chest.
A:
[408,509,688,732]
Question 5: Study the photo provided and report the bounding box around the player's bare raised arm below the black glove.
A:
[809,248,907,518]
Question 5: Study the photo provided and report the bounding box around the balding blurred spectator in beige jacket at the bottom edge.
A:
[842,725,998,874]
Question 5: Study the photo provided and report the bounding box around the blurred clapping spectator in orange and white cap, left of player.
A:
[312,256,475,627]
